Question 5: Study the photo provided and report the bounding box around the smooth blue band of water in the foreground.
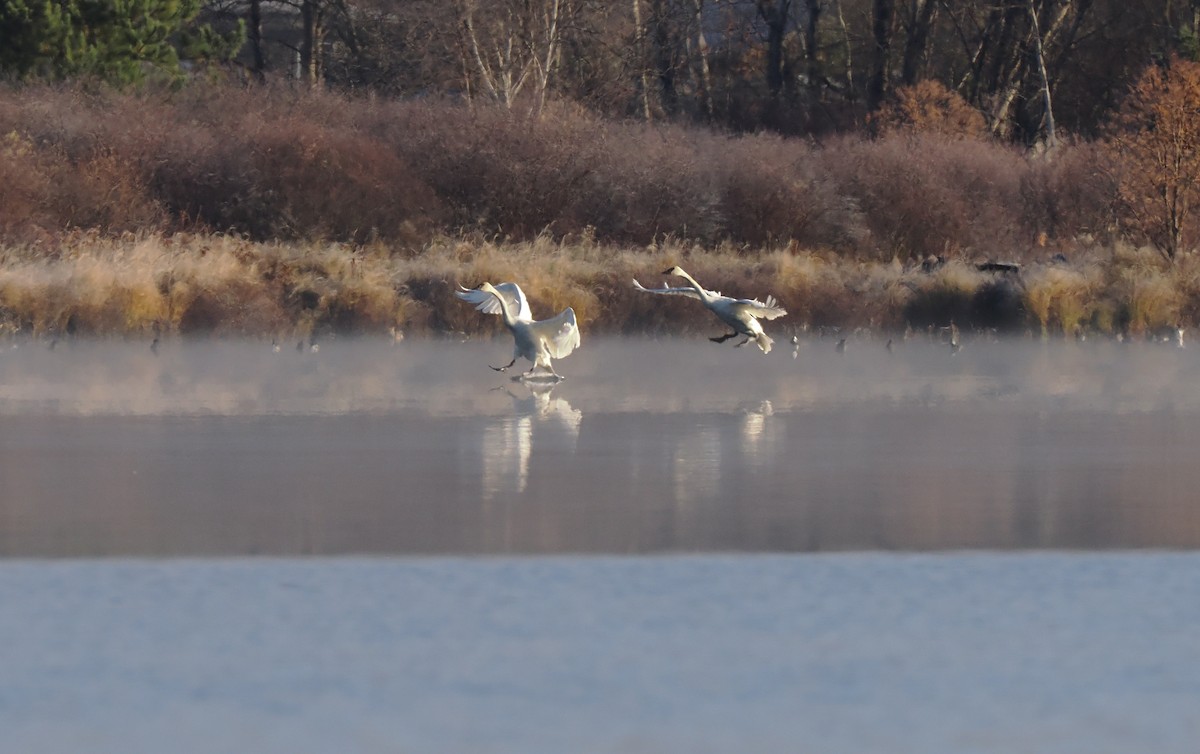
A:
[0,552,1200,754]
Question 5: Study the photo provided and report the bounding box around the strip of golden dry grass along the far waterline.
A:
[0,234,1200,337]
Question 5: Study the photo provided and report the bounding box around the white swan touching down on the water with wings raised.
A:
[455,282,580,379]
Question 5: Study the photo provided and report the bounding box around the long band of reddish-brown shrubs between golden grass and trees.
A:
[0,78,1161,261]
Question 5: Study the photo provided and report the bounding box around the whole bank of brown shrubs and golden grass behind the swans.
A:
[0,61,1200,335]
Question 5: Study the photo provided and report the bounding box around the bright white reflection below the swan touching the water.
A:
[482,383,583,499]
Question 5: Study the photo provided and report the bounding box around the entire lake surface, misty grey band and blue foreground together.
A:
[0,337,1200,754]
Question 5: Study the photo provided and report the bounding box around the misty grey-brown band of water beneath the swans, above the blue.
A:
[0,339,1200,556]
